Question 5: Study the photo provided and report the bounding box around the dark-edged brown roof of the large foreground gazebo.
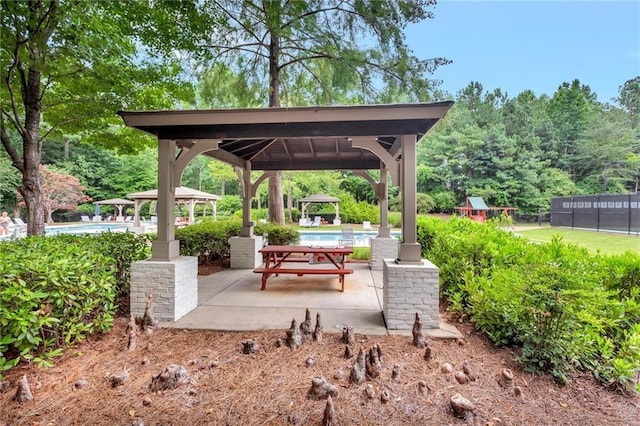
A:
[118,101,453,170]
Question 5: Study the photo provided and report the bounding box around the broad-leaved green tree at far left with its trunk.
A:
[0,0,188,235]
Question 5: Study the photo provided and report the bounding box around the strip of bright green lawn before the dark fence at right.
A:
[515,227,640,254]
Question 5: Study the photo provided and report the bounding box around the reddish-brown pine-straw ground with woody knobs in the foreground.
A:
[0,265,640,426]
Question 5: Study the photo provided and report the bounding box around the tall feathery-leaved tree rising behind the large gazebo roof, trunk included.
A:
[198,0,446,223]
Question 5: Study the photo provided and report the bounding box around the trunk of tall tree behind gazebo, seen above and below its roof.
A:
[268,31,284,225]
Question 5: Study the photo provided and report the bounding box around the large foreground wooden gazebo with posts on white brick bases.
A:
[118,101,453,330]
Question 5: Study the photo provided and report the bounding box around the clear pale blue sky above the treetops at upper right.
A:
[405,0,640,102]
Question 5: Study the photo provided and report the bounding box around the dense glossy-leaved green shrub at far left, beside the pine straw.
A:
[0,235,116,378]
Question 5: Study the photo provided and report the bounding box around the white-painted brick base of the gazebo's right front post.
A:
[382,259,440,330]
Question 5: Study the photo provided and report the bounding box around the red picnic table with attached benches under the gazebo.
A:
[253,245,353,292]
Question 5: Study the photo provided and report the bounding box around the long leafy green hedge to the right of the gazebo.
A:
[418,218,640,390]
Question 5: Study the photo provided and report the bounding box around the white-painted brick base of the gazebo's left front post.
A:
[130,256,198,322]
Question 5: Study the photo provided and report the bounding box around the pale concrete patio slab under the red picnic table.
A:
[168,263,460,338]
